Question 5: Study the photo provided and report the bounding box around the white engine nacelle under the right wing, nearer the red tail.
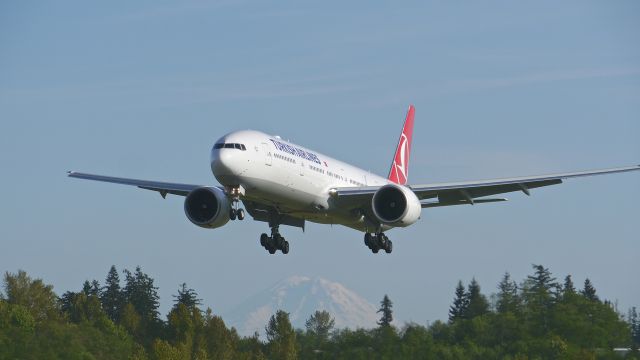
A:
[371,184,422,227]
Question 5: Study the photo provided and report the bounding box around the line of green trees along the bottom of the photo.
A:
[0,265,640,360]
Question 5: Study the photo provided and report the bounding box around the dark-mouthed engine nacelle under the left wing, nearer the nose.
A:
[184,187,231,229]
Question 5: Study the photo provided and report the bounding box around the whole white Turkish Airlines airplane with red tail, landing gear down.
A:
[68,106,640,254]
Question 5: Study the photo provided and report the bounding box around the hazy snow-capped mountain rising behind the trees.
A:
[223,276,379,336]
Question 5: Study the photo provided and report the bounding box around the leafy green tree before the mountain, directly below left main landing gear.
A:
[265,310,297,359]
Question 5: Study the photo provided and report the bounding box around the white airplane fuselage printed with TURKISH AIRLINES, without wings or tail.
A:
[211,130,391,231]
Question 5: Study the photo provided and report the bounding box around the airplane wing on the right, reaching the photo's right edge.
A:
[330,165,640,208]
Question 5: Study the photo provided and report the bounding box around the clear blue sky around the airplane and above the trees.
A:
[0,1,640,324]
